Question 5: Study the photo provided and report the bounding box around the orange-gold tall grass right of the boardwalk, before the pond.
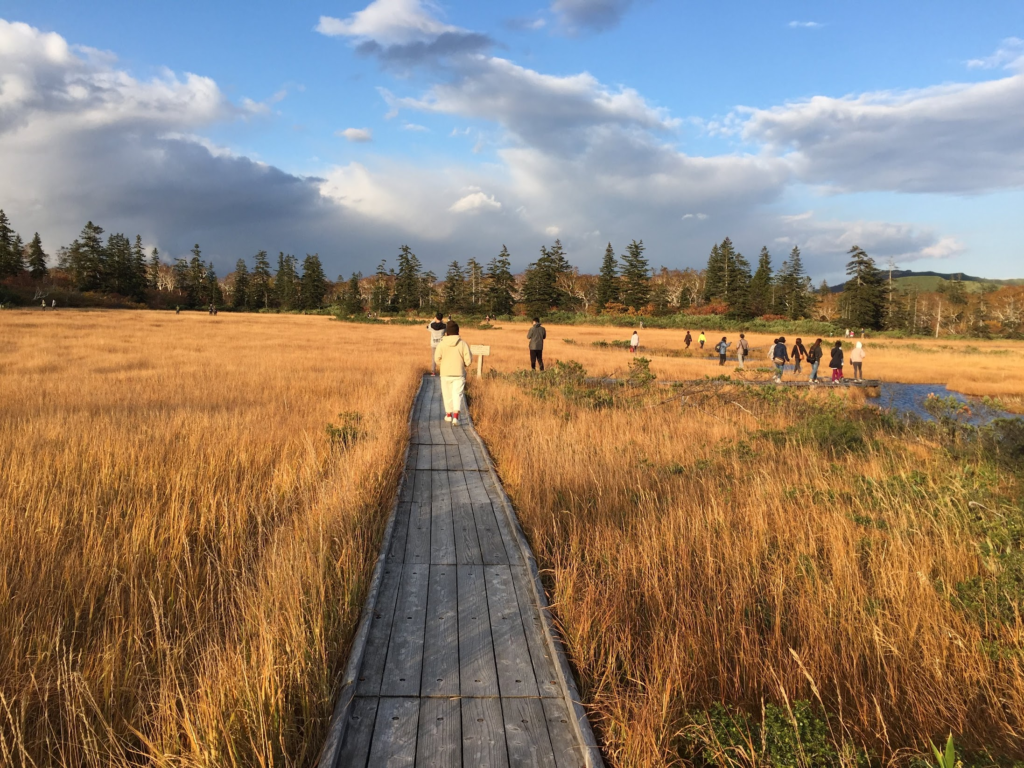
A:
[473,378,1024,766]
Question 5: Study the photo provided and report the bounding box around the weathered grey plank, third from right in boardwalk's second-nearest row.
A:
[457,565,499,696]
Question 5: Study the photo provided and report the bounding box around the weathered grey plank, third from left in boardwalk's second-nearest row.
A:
[420,565,460,696]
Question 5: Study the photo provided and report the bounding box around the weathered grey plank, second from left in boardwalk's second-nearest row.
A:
[381,564,430,696]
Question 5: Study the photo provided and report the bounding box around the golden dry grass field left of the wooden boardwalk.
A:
[0,312,420,766]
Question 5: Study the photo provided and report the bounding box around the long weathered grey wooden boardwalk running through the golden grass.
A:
[319,376,602,768]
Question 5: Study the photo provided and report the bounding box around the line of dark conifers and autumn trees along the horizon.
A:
[0,210,1024,334]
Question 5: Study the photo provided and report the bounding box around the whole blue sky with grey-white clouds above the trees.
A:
[0,0,1024,283]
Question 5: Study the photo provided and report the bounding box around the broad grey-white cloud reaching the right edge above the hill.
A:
[739,61,1024,194]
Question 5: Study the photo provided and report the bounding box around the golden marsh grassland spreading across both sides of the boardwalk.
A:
[0,311,1024,766]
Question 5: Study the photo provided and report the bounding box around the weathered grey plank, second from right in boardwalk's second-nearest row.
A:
[483,565,539,698]
